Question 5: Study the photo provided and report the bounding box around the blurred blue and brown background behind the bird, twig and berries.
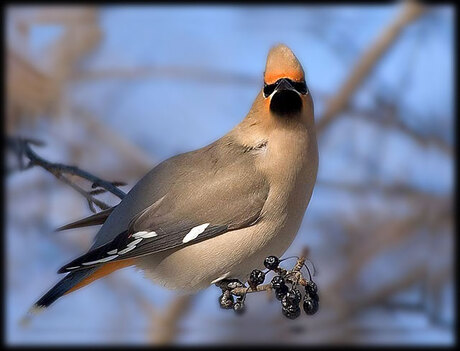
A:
[5,3,455,345]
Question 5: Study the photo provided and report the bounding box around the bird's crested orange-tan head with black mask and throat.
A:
[262,44,313,118]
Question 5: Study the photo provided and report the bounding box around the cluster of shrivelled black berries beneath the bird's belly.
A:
[218,256,319,319]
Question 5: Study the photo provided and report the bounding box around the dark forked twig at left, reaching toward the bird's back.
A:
[7,137,126,212]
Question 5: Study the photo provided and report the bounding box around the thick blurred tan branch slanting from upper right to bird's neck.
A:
[316,1,425,134]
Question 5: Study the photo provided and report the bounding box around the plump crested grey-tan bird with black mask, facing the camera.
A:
[29,44,318,320]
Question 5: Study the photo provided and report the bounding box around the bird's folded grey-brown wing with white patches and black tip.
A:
[59,139,269,273]
